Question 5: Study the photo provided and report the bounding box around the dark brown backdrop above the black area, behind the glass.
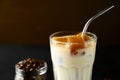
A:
[0,0,120,45]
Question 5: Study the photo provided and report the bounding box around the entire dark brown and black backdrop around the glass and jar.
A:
[0,0,120,80]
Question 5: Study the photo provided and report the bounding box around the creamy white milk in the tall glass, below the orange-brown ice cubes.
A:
[50,34,96,80]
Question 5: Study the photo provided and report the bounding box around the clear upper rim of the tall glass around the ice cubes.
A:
[49,31,97,44]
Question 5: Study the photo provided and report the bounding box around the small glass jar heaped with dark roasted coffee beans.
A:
[15,58,47,80]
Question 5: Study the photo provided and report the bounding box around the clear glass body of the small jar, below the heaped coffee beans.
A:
[15,61,47,80]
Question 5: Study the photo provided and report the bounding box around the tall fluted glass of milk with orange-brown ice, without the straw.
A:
[50,31,97,80]
